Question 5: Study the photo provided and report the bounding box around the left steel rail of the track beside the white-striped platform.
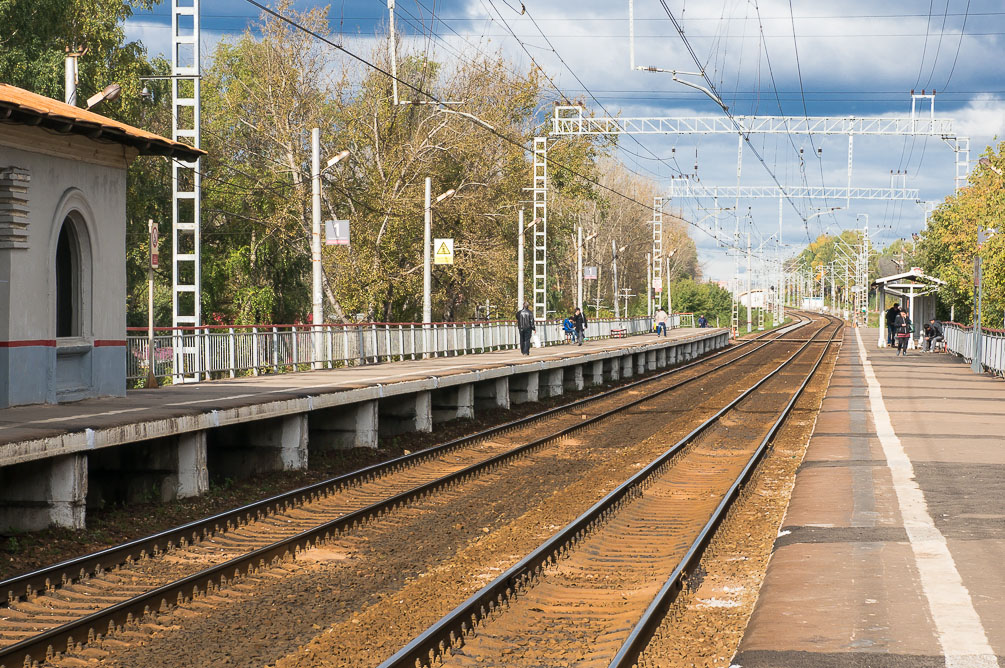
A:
[378,316,830,668]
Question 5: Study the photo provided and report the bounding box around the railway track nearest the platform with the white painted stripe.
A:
[380,318,842,668]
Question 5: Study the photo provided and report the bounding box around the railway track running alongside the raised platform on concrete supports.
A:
[0,315,820,666]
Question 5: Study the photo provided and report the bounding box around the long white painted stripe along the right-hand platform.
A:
[855,329,998,668]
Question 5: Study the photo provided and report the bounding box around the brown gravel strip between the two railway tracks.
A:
[43,331,820,666]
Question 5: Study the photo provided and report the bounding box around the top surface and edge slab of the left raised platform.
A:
[0,328,725,465]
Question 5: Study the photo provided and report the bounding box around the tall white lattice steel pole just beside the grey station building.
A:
[171,0,202,383]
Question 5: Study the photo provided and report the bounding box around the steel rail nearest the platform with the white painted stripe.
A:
[608,315,843,668]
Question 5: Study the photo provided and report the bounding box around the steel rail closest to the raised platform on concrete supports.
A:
[0,322,763,601]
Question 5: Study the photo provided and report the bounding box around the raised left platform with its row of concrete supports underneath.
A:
[0,328,729,531]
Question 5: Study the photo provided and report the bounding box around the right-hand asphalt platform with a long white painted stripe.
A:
[733,329,1005,668]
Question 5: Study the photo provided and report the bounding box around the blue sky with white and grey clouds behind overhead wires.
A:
[127,0,1005,279]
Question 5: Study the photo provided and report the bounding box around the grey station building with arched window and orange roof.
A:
[0,83,204,408]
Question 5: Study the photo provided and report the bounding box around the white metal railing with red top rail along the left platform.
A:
[126,313,659,382]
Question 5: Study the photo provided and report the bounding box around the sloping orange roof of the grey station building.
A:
[0,83,206,161]
